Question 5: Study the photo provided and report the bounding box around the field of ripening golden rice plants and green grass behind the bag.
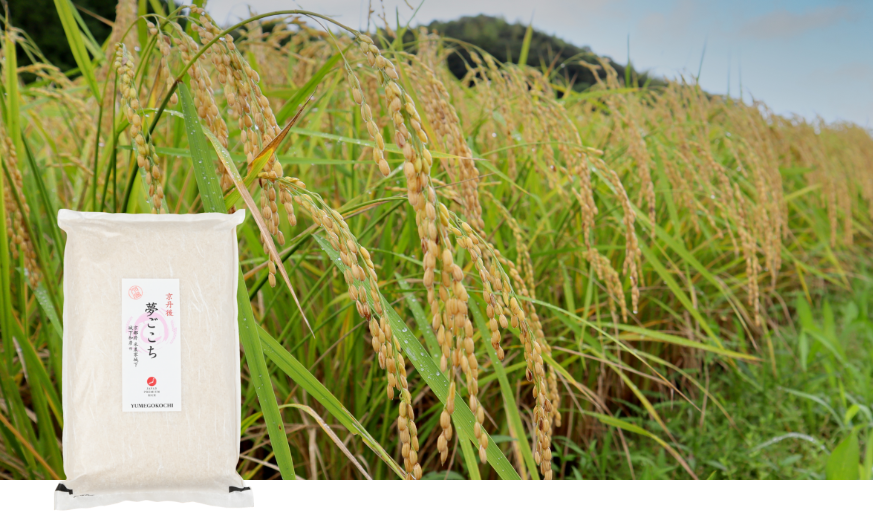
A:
[0,0,873,480]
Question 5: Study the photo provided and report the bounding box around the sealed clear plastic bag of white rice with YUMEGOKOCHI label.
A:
[54,210,254,510]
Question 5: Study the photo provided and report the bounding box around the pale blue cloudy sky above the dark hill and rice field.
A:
[207,0,873,129]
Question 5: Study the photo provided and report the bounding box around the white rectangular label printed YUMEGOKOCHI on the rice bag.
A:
[121,279,182,412]
